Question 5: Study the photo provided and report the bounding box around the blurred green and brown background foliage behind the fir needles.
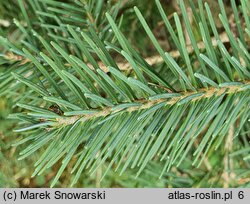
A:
[0,0,250,187]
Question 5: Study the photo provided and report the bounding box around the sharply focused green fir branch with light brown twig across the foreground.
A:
[0,0,250,186]
